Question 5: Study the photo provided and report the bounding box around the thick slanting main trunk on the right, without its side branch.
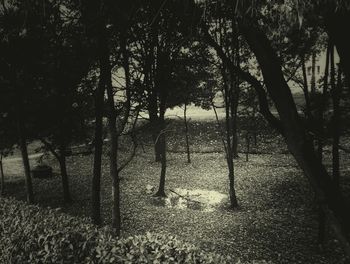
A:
[241,21,350,250]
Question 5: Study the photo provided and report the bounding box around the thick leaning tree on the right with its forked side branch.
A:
[201,0,350,254]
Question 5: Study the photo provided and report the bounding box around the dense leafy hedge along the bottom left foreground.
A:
[0,198,232,263]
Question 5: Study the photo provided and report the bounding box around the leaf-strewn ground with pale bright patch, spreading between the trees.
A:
[5,120,350,264]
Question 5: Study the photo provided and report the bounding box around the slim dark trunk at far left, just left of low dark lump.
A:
[17,114,34,203]
